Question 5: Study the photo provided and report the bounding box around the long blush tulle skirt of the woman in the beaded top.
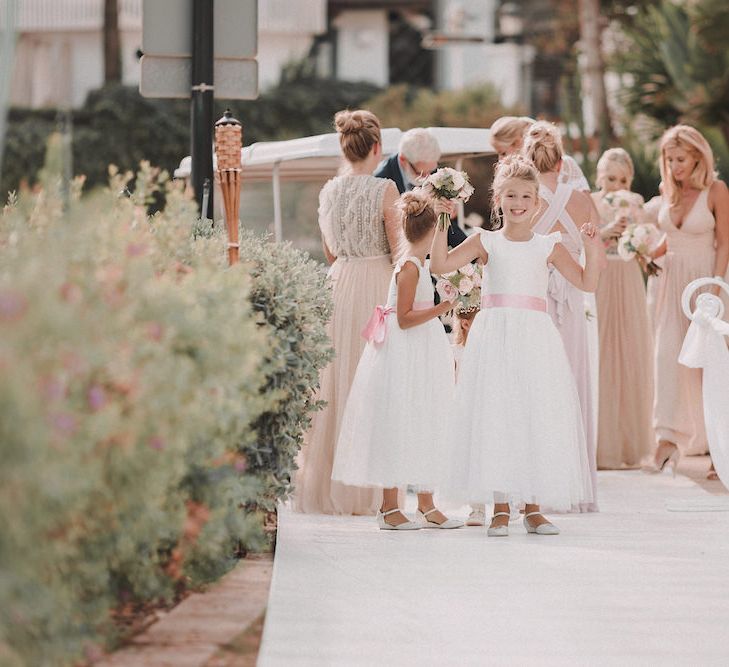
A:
[293,256,392,514]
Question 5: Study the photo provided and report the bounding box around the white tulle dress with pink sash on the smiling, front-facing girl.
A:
[444,231,592,511]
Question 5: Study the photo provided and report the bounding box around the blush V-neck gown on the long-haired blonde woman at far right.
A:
[653,189,716,455]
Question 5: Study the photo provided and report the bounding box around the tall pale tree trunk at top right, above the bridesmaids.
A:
[579,0,613,148]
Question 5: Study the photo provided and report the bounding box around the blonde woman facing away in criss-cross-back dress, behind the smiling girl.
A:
[523,121,607,512]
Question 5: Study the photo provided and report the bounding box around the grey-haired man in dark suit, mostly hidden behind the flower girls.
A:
[374,127,467,248]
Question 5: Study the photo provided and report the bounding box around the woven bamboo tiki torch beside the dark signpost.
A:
[215,109,243,265]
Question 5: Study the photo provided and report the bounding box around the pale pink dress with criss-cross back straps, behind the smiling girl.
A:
[533,183,598,512]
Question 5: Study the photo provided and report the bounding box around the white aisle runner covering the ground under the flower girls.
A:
[258,471,729,667]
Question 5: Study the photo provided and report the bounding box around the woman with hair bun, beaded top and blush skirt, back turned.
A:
[294,110,401,514]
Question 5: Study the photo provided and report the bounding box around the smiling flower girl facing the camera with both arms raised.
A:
[431,156,604,536]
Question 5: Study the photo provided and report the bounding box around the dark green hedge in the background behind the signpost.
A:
[0,66,378,199]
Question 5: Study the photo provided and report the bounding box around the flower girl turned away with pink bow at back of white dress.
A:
[332,192,463,530]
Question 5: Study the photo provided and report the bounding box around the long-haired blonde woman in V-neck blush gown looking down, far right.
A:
[648,125,729,472]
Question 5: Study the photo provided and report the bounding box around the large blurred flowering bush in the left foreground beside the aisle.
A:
[0,155,329,665]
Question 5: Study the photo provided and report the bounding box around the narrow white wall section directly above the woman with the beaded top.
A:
[334,10,390,86]
